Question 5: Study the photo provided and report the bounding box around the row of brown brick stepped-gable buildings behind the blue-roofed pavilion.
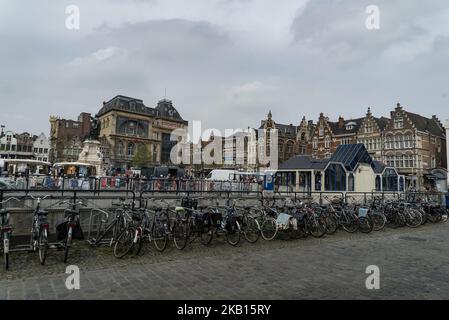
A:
[261,104,447,190]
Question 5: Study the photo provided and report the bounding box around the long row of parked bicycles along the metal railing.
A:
[0,195,448,269]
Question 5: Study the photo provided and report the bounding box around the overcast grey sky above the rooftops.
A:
[0,0,449,134]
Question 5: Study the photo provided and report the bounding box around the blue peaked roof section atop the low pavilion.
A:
[330,143,374,171]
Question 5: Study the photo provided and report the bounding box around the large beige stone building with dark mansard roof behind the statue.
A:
[97,95,188,169]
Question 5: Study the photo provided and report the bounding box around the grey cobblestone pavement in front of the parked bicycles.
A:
[0,223,449,300]
